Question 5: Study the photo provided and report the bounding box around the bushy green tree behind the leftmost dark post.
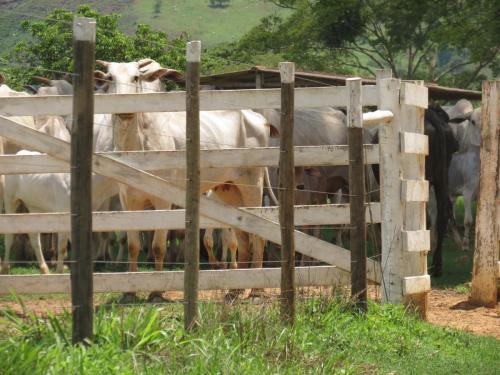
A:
[2,6,187,88]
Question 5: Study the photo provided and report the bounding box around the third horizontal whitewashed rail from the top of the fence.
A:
[0,202,380,234]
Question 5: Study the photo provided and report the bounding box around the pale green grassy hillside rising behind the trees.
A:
[0,0,286,53]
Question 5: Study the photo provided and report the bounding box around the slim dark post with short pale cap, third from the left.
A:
[279,62,295,324]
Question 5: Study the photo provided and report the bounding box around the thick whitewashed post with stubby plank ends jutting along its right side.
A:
[377,74,430,318]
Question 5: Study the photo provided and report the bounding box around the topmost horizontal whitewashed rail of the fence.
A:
[0,86,377,116]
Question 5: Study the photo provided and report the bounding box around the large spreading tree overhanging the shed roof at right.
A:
[240,0,500,87]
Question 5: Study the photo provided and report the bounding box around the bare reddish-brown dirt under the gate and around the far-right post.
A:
[0,288,500,339]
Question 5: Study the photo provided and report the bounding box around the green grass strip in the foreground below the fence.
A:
[0,298,500,375]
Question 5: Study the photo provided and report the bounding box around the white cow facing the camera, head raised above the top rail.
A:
[98,61,278,297]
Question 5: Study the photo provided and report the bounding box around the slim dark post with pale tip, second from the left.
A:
[184,41,201,330]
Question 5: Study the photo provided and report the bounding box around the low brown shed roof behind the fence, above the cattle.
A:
[200,66,481,100]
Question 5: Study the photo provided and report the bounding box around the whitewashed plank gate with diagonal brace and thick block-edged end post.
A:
[0,16,458,340]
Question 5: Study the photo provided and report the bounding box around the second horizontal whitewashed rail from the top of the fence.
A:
[0,144,379,174]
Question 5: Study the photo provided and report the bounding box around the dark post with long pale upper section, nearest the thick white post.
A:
[346,78,368,311]
